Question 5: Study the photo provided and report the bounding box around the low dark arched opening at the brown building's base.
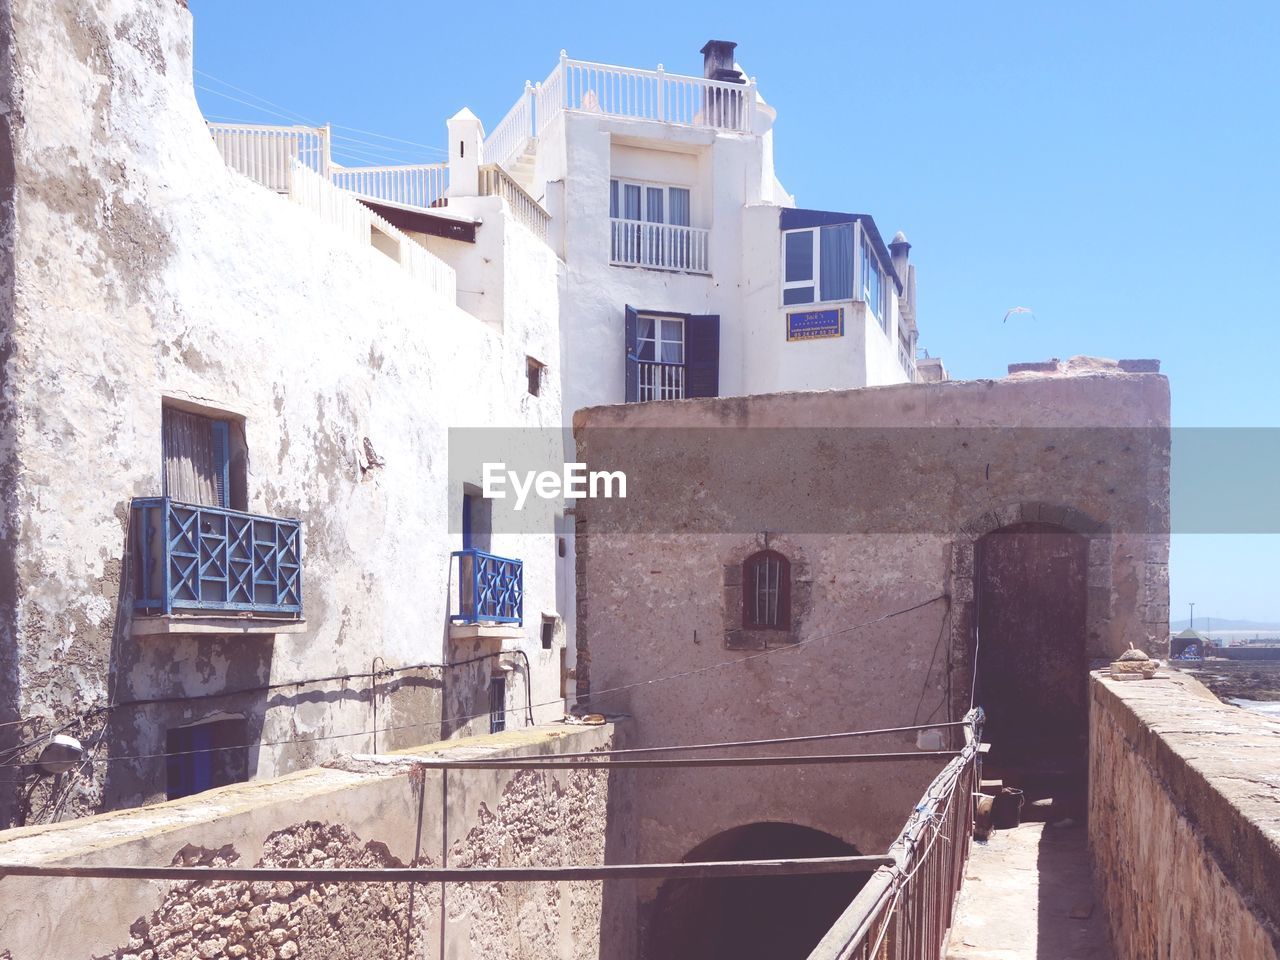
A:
[644,823,867,960]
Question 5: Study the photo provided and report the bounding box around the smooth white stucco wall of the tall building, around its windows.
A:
[534,101,905,417]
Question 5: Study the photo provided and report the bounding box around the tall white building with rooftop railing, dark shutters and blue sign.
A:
[204,41,946,716]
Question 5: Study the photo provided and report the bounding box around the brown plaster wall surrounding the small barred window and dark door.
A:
[575,375,1169,952]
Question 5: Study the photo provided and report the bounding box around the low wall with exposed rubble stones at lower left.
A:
[0,726,627,960]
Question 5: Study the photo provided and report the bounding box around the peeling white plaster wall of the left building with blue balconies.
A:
[0,0,561,829]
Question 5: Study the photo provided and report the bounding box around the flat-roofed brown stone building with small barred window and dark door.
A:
[575,361,1169,957]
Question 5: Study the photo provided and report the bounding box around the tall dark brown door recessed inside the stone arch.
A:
[977,524,1089,819]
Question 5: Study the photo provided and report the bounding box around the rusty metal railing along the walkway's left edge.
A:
[809,709,982,960]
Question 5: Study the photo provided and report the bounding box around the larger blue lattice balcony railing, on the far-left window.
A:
[133,497,302,617]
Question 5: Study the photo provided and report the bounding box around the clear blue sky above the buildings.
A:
[191,0,1280,621]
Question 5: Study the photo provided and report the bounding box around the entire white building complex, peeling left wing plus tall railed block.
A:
[0,15,942,819]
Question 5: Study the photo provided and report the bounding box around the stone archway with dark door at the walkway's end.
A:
[952,503,1111,817]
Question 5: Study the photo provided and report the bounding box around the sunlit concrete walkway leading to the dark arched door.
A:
[947,823,1112,960]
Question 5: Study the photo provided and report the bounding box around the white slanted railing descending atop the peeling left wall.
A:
[289,161,458,303]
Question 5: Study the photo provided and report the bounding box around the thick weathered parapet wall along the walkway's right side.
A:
[1089,675,1280,960]
